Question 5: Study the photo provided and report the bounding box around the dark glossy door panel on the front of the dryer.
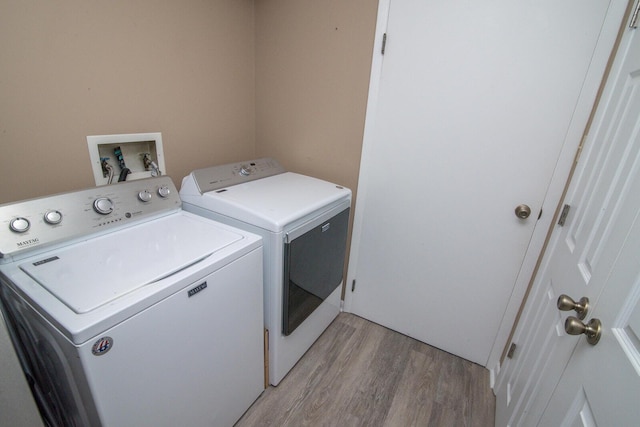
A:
[282,208,349,335]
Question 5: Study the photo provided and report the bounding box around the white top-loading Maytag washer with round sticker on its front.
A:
[0,177,264,427]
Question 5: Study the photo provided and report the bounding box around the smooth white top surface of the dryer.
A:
[196,172,351,232]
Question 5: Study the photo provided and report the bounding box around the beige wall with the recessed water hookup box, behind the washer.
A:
[0,0,255,203]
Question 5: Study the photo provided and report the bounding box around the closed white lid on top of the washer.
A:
[20,213,243,313]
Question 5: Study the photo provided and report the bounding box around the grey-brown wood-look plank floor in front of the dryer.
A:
[236,313,495,427]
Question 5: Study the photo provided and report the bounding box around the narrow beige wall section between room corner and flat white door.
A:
[256,0,378,196]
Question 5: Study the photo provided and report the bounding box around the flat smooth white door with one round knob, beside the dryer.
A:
[345,0,620,366]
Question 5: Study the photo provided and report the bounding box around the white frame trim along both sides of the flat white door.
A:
[343,0,634,380]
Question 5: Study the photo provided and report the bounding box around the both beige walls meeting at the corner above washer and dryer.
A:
[0,0,377,203]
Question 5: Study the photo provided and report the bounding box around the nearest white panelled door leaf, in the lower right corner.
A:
[539,198,640,427]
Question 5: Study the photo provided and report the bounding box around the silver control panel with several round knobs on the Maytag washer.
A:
[0,176,182,258]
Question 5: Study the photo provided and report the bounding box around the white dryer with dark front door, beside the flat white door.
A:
[180,158,351,385]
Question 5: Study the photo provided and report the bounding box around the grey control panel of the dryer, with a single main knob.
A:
[191,158,286,194]
